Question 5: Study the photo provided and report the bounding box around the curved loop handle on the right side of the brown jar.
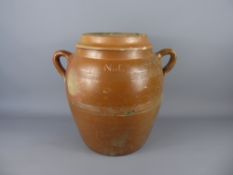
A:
[156,48,176,75]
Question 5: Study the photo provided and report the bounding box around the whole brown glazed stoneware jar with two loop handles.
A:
[53,33,176,156]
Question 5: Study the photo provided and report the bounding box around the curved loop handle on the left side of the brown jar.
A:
[53,50,72,78]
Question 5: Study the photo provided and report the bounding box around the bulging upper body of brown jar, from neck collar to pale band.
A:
[66,58,163,105]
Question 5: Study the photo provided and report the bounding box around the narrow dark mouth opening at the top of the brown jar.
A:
[83,32,147,37]
